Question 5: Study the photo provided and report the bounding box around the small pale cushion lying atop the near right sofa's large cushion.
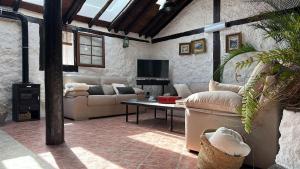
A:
[209,80,242,93]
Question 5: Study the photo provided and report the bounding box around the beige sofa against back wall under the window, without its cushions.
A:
[63,75,143,120]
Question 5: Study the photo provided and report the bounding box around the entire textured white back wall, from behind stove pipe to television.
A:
[0,15,153,119]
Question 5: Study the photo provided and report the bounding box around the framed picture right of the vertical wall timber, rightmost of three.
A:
[226,32,242,53]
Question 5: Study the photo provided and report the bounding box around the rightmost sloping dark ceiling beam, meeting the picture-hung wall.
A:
[145,0,193,38]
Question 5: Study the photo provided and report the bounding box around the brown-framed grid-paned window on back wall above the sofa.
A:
[77,33,105,68]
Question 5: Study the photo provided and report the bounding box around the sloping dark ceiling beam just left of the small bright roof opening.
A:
[124,0,157,35]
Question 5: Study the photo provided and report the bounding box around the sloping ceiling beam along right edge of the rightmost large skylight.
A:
[108,0,140,33]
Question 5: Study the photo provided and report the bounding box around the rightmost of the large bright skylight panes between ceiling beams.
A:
[100,0,130,22]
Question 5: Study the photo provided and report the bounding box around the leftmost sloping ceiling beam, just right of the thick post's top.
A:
[63,0,86,24]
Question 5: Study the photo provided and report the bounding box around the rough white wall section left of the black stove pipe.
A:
[0,19,22,118]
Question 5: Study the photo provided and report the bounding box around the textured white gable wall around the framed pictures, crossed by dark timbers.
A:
[152,0,274,85]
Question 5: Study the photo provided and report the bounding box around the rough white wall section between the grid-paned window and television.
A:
[66,37,151,85]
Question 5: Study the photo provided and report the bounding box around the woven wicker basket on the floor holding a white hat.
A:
[198,130,245,169]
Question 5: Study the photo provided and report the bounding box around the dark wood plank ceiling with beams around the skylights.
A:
[0,0,193,38]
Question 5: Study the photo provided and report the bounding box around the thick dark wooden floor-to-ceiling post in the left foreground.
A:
[44,0,64,145]
